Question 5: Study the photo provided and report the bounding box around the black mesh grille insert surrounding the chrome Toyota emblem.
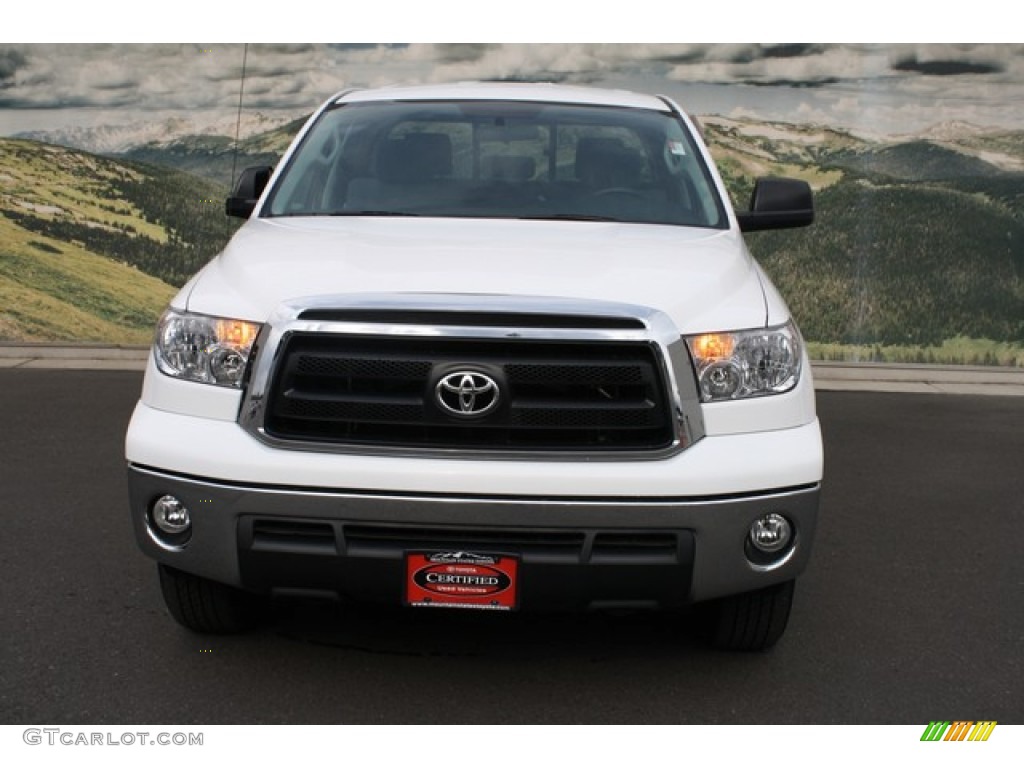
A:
[264,333,674,452]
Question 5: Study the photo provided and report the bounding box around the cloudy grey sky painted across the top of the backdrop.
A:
[0,43,1024,135]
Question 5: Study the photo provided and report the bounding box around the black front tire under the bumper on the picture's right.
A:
[707,580,796,651]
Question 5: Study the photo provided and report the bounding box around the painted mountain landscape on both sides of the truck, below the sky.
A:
[0,116,1024,366]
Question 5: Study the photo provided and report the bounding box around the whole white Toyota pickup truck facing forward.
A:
[126,84,822,650]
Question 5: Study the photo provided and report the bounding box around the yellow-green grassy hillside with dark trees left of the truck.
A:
[0,139,229,344]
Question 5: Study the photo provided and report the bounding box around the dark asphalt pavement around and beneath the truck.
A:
[0,368,1024,727]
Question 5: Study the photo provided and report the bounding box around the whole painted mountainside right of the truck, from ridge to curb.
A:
[707,119,1024,365]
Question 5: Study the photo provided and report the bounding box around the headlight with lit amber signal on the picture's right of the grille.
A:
[686,323,803,402]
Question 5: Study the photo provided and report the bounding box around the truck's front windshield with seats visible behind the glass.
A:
[263,101,728,228]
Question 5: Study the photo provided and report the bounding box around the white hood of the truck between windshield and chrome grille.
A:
[182,217,781,334]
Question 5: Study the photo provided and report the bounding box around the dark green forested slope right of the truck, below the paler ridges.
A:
[748,181,1024,346]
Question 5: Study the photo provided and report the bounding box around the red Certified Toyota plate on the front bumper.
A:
[406,552,519,610]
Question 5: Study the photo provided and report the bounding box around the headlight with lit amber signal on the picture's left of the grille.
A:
[154,309,260,387]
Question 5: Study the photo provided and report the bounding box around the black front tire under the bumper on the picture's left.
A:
[157,563,260,635]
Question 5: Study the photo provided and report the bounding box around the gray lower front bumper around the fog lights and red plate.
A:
[128,466,819,608]
